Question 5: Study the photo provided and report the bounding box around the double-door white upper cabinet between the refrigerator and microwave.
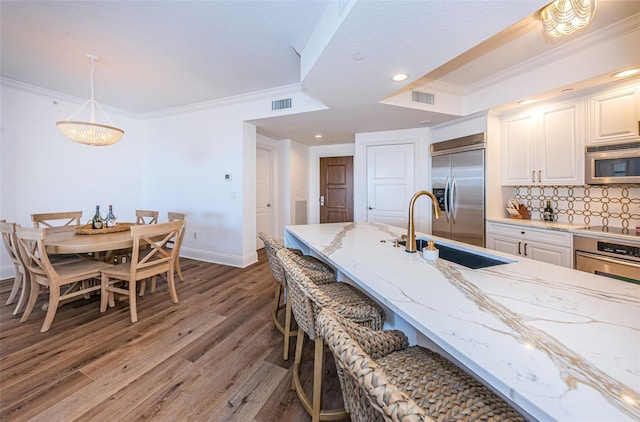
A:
[501,100,585,185]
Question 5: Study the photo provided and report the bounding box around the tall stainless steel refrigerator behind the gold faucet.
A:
[431,133,486,247]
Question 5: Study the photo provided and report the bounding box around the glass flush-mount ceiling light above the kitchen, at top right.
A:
[540,0,597,39]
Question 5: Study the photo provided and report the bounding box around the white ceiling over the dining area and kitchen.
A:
[0,0,640,145]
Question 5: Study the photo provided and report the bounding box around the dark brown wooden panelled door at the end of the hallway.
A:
[320,157,353,223]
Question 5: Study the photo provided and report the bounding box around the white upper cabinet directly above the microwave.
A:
[587,85,640,144]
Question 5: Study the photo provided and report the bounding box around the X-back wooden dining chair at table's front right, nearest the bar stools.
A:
[100,221,184,322]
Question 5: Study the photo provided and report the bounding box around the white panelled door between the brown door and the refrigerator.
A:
[367,144,415,227]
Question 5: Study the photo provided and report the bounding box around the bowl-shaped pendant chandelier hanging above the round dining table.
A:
[56,54,124,146]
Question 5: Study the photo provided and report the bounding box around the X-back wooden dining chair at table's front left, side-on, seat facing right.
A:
[16,226,112,333]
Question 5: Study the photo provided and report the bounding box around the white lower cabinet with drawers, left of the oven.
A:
[486,222,573,268]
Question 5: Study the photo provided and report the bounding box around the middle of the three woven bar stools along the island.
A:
[277,249,384,422]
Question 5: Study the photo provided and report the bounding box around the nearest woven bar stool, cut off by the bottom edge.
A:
[316,309,526,422]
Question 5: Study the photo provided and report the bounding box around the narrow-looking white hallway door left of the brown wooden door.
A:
[256,148,273,249]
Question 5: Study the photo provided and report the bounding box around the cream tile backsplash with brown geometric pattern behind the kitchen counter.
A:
[515,185,640,229]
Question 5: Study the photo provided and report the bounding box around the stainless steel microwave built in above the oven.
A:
[584,141,640,185]
